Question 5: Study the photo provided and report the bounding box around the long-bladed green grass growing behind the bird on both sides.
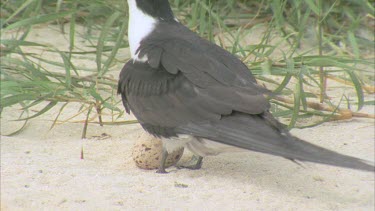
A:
[0,0,375,135]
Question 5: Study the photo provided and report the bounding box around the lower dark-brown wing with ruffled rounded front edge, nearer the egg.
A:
[118,60,269,135]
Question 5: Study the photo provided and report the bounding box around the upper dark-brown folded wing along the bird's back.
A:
[138,22,266,88]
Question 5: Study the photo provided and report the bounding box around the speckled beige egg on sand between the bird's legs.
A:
[132,133,184,169]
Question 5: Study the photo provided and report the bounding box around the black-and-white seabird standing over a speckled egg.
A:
[118,0,374,173]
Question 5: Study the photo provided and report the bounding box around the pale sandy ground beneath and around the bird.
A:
[1,24,375,210]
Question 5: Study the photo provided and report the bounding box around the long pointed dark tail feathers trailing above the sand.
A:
[181,115,375,171]
